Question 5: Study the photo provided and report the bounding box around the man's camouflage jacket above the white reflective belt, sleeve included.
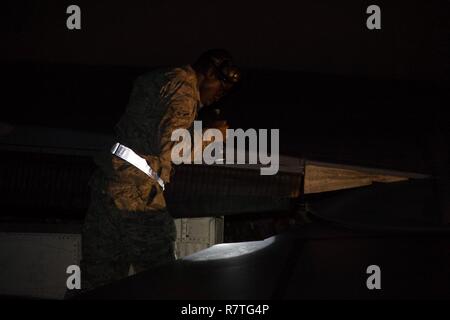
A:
[115,65,200,182]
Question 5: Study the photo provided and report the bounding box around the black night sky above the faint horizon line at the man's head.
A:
[1,0,449,80]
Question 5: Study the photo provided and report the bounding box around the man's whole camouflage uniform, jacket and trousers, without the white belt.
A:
[81,66,200,289]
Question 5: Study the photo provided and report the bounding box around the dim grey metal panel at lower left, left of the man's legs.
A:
[0,233,81,299]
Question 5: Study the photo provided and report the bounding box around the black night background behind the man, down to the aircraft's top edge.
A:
[1,0,450,172]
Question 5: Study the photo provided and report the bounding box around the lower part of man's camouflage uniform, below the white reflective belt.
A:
[77,156,176,291]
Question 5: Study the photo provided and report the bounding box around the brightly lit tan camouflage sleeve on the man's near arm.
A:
[159,77,198,182]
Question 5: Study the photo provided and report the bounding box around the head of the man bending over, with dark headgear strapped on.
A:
[192,49,240,106]
